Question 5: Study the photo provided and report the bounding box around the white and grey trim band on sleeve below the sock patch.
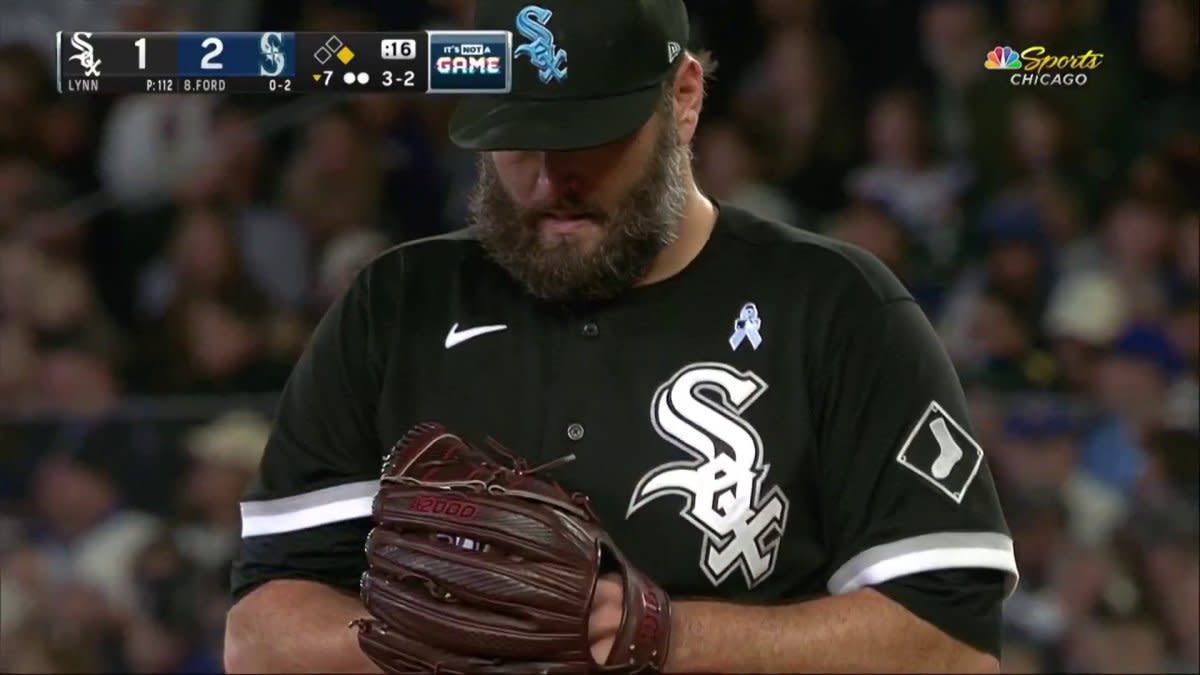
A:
[827,532,1020,597]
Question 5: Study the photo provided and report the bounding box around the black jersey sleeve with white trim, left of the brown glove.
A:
[232,267,382,598]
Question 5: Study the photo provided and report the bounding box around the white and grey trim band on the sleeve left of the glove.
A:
[241,480,379,538]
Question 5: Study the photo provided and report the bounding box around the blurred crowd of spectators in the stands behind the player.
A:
[0,0,1200,673]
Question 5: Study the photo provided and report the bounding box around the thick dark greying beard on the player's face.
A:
[469,109,691,304]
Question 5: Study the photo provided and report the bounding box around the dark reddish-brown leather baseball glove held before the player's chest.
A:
[355,424,671,674]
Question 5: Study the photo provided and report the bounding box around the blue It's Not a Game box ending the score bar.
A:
[430,30,512,94]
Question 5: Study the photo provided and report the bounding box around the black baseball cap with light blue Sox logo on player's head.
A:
[450,0,689,150]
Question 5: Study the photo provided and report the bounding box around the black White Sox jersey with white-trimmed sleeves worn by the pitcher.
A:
[234,204,1016,652]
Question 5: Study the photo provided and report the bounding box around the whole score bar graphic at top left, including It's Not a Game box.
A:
[56,31,512,94]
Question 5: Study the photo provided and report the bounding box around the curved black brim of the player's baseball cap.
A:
[450,85,662,151]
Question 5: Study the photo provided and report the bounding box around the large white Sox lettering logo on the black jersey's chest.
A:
[626,363,787,587]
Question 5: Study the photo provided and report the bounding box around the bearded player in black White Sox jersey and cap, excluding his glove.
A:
[226,0,1018,673]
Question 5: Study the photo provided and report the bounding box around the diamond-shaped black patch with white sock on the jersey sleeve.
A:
[896,401,983,503]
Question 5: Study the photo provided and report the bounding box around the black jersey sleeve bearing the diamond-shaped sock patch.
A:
[817,297,1018,644]
